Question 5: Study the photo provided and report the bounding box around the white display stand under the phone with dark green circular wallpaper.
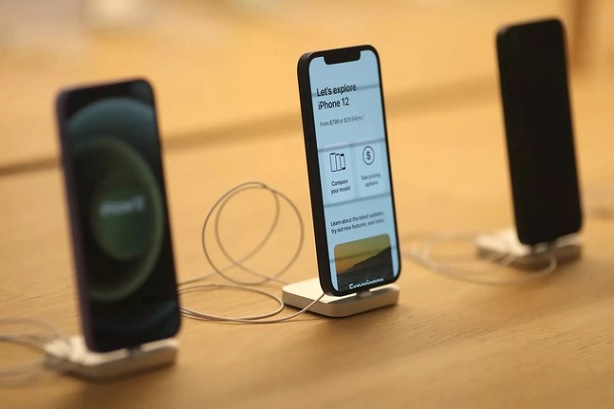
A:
[45,335,178,381]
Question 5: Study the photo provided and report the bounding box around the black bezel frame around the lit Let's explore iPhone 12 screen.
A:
[297,45,401,296]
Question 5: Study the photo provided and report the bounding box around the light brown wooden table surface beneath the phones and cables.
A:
[0,1,614,409]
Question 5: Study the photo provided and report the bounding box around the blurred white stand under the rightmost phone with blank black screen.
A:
[476,228,582,268]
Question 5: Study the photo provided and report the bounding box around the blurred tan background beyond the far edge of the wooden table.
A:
[0,0,614,175]
